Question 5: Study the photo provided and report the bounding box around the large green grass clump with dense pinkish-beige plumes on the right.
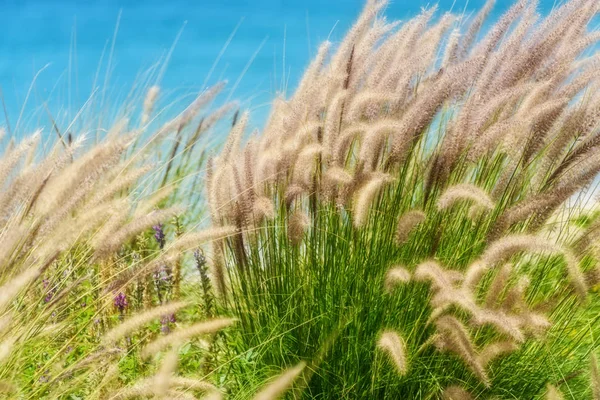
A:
[202,1,599,398]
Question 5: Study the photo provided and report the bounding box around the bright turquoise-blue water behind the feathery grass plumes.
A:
[0,0,554,134]
